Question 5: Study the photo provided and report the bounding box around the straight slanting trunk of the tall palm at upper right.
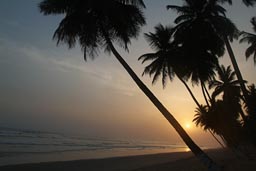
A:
[224,36,248,105]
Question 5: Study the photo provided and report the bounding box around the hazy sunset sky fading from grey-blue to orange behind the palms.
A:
[0,0,256,145]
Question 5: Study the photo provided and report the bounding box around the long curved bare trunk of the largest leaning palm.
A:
[104,34,221,171]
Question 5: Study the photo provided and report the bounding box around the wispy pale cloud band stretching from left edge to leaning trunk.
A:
[0,38,138,96]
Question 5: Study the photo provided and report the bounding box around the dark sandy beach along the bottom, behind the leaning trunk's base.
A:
[0,150,256,171]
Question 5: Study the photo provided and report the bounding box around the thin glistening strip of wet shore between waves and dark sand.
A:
[0,147,194,166]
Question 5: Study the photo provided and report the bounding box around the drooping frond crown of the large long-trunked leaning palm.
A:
[39,0,146,60]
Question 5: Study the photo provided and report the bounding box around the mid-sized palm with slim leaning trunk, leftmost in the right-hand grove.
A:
[139,24,200,106]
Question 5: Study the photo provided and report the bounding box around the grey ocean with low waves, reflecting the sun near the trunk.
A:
[0,127,189,166]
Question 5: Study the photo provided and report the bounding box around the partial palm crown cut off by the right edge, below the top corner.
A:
[240,17,256,64]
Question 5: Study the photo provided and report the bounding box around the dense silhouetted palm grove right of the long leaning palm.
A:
[139,0,256,155]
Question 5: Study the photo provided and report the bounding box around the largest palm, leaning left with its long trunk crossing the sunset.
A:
[39,0,220,170]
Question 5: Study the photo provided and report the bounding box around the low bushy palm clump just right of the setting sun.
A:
[193,100,241,148]
